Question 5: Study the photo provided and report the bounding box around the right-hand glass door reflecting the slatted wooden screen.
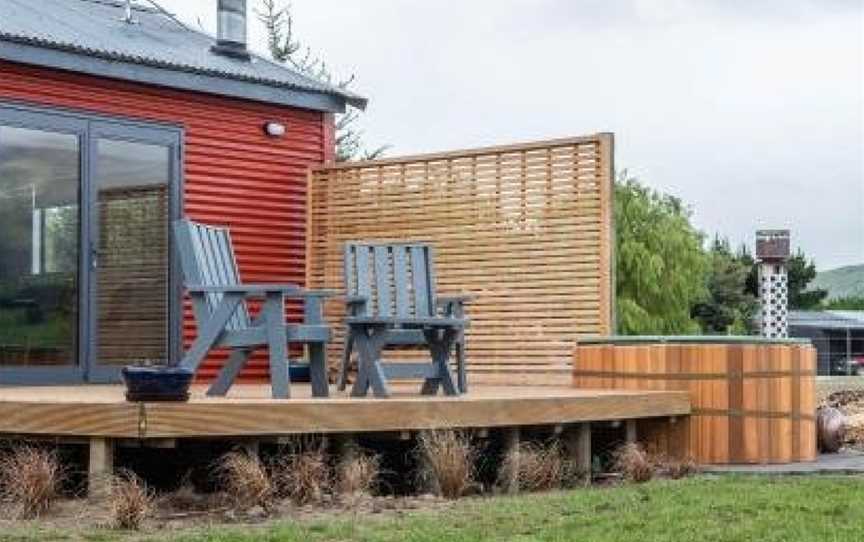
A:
[90,122,179,380]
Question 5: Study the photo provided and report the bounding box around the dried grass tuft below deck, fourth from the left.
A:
[270,439,333,505]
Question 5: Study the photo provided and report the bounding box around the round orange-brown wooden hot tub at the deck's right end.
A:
[573,338,816,464]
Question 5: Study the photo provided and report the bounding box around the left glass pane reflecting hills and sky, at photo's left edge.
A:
[0,126,80,365]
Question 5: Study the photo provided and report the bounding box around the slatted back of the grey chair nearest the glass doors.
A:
[176,220,252,331]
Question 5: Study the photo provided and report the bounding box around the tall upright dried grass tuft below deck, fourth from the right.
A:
[417,430,477,499]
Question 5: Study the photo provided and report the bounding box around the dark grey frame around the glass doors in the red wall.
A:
[0,100,184,386]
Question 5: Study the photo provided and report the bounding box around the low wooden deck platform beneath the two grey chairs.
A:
[0,385,690,439]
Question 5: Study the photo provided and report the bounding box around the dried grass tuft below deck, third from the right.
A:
[498,441,580,491]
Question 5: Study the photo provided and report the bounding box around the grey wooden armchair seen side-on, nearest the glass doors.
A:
[174,220,335,399]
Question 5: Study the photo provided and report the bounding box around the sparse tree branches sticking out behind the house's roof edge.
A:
[256,0,387,162]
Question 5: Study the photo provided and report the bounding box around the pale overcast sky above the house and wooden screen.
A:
[161,0,864,269]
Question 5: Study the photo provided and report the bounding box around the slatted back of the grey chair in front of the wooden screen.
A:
[345,243,437,319]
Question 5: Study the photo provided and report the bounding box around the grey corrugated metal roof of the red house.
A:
[0,0,366,111]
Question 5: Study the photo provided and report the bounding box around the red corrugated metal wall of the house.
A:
[0,61,324,379]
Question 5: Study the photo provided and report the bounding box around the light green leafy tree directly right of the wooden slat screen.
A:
[615,171,710,335]
